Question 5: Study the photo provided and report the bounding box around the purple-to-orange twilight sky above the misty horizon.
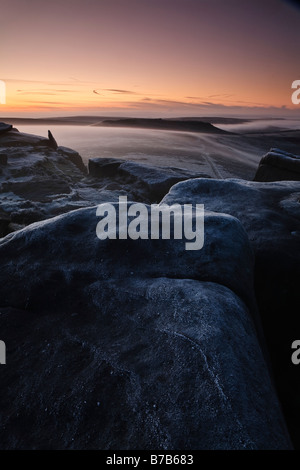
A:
[0,0,300,117]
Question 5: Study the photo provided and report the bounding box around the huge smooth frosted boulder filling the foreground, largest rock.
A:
[0,208,290,450]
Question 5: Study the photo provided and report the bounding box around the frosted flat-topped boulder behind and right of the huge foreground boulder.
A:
[164,179,300,447]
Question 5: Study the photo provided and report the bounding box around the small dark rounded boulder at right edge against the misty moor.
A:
[254,149,300,181]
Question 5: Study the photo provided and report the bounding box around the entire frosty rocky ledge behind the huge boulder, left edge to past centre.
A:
[0,124,210,236]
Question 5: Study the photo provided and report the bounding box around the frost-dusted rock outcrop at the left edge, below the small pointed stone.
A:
[0,124,89,232]
